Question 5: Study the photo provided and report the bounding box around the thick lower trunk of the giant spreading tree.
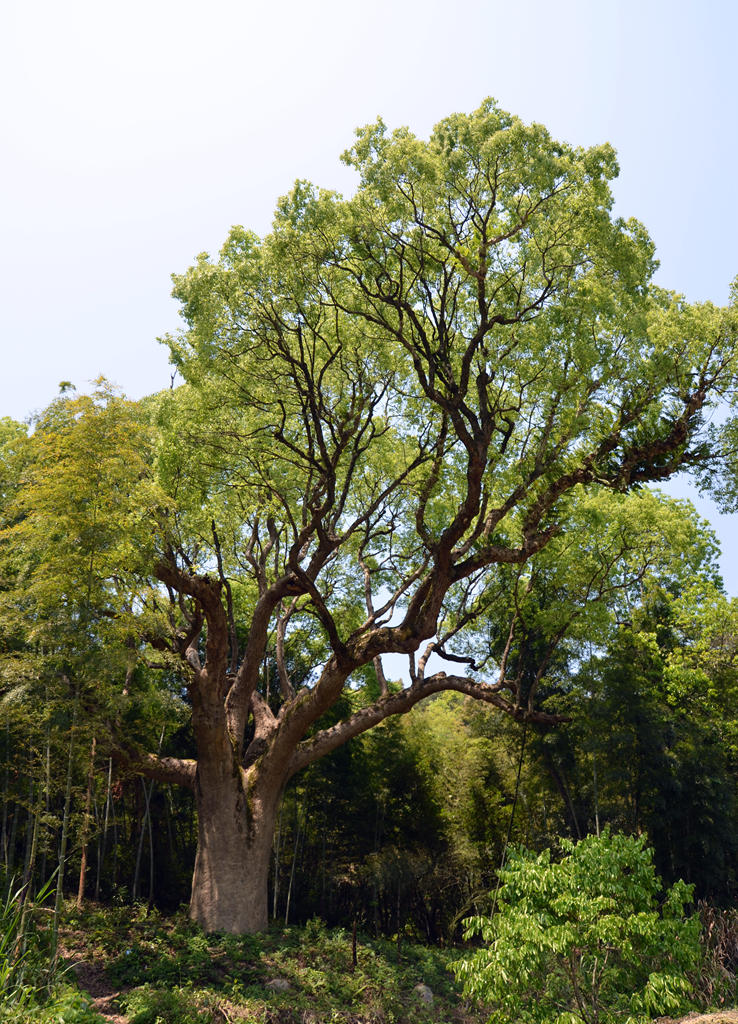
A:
[189,760,281,934]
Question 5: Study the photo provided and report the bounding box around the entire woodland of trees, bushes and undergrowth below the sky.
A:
[0,101,738,1024]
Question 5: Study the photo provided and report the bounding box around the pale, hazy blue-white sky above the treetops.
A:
[0,0,738,594]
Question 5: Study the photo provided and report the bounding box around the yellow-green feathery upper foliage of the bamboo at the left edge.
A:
[0,379,170,737]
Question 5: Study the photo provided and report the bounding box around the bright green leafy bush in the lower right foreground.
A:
[454,834,700,1024]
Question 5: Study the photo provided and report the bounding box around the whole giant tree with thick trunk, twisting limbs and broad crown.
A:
[131,102,736,932]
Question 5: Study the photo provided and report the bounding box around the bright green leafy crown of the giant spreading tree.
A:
[158,94,736,737]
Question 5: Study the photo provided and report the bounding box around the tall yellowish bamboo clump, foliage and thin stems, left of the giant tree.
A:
[0,380,188,911]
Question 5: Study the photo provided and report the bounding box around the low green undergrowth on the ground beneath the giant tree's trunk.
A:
[62,907,476,1024]
